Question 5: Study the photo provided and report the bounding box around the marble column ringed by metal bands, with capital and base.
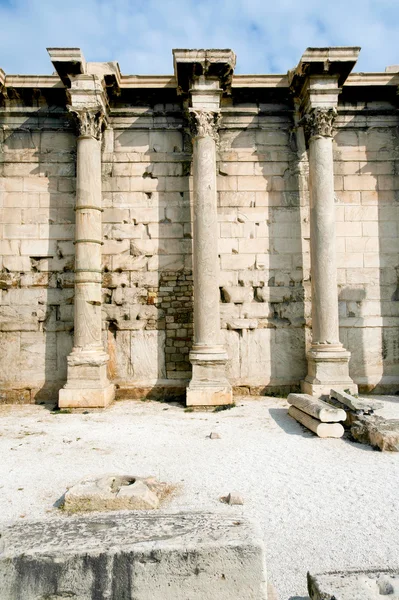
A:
[59,107,115,408]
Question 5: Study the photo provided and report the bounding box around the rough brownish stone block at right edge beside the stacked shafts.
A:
[351,415,399,452]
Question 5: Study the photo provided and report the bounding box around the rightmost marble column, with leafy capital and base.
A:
[302,107,357,395]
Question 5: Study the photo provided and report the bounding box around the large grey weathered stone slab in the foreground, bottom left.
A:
[0,512,267,600]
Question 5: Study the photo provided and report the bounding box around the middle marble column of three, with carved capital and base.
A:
[187,109,232,406]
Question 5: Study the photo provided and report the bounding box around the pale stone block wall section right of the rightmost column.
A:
[336,96,399,393]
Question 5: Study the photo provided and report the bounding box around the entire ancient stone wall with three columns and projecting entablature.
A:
[0,47,399,408]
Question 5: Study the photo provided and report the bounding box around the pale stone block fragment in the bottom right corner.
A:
[308,570,399,600]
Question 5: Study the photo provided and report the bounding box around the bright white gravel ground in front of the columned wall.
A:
[0,397,399,600]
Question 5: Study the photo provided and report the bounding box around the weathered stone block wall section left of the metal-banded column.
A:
[0,92,76,403]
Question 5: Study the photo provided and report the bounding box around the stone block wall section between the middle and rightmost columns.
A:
[219,99,309,395]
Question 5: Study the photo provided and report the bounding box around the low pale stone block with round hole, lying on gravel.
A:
[63,475,167,512]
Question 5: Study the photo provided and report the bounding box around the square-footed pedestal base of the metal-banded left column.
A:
[58,348,115,408]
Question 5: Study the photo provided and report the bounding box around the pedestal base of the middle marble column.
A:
[186,347,233,406]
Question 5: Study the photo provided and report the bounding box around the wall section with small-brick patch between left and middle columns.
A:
[103,90,193,399]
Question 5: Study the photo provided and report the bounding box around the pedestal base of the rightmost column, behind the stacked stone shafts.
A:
[301,348,358,397]
